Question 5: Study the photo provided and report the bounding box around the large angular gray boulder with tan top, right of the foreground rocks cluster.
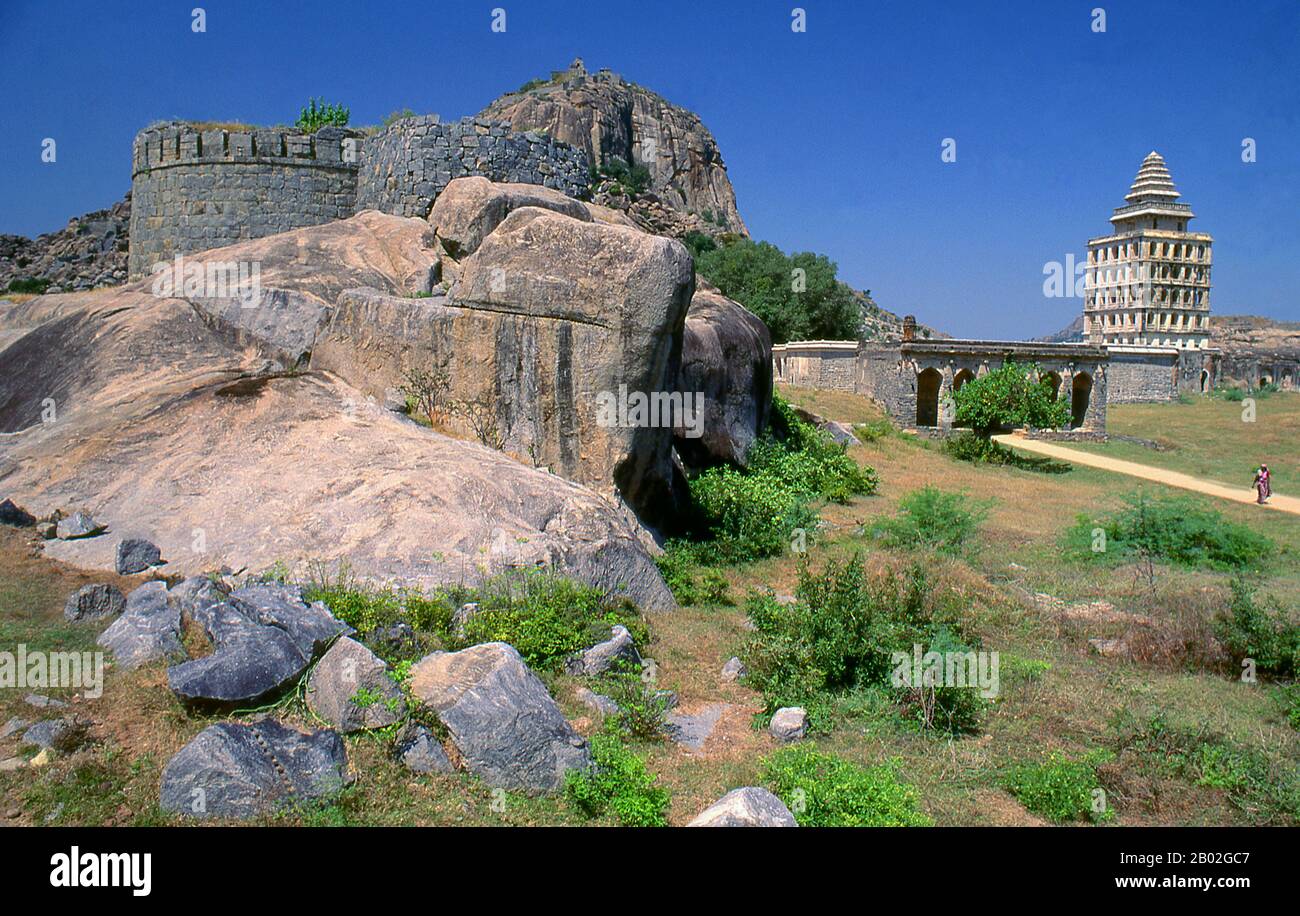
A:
[410,642,592,794]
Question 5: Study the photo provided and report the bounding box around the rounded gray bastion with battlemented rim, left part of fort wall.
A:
[127,122,361,277]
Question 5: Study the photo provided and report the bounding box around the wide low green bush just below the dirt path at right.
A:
[1066,491,1274,570]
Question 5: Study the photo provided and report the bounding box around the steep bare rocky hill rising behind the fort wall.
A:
[480,60,748,235]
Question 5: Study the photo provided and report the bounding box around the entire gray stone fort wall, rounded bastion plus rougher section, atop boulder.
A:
[127,116,589,278]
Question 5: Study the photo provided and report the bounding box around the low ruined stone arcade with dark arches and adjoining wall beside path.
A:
[772,316,1108,435]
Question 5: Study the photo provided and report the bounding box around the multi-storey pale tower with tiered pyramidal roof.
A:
[1083,151,1214,350]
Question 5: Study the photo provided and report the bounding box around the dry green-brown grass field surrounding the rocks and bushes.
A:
[0,381,1300,825]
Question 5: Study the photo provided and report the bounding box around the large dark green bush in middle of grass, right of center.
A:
[740,556,983,733]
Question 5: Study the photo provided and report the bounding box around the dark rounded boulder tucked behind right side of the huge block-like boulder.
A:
[673,290,772,466]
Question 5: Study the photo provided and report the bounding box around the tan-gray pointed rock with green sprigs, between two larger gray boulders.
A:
[307,637,406,734]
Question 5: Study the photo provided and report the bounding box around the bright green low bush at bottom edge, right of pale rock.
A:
[763,744,932,826]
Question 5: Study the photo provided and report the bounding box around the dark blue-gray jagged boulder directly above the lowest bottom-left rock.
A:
[166,585,351,709]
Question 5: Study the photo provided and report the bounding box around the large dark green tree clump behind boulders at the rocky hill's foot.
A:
[696,237,862,343]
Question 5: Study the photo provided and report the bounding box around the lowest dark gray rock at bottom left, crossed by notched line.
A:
[160,719,351,819]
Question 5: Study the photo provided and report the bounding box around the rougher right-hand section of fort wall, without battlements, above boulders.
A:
[356,114,590,220]
